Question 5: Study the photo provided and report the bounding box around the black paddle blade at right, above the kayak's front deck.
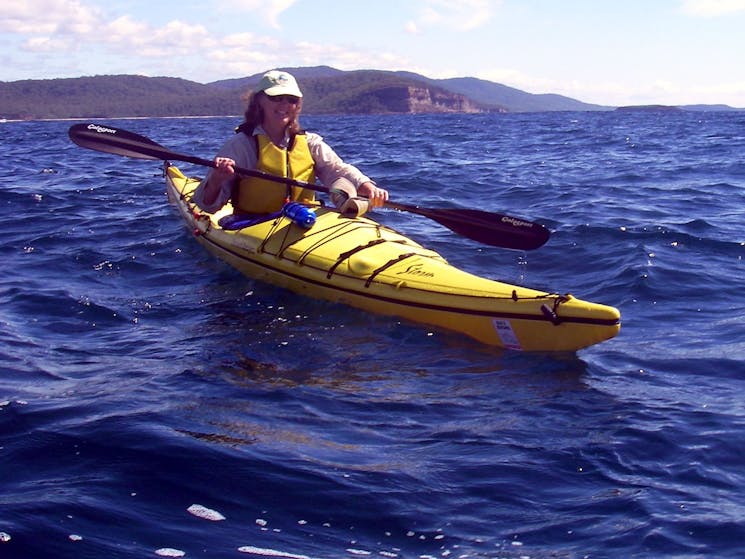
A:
[386,202,551,250]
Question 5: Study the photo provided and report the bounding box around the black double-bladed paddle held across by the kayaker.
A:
[69,124,550,250]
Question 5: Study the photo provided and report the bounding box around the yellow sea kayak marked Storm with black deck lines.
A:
[165,164,621,351]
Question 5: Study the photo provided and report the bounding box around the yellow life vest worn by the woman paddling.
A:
[233,133,316,214]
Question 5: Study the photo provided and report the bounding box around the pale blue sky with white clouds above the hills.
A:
[0,0,745,108]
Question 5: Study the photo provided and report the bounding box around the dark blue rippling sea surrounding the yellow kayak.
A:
[0,112,745,559]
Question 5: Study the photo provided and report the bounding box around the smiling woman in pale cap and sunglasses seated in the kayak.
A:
[194,70,388,215]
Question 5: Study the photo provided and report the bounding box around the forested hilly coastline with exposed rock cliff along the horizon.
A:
[0,66,731,119]
